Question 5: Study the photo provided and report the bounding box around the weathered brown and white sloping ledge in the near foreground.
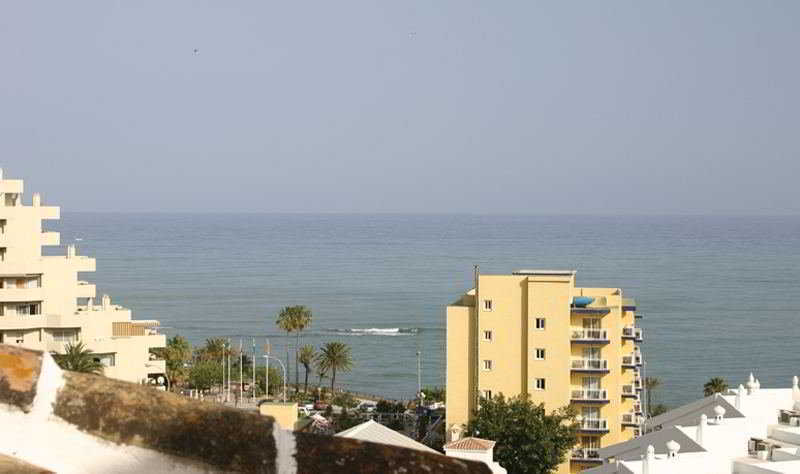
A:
[0,345,489,474]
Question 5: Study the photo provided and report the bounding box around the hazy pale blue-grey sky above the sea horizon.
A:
[0,0,800,214]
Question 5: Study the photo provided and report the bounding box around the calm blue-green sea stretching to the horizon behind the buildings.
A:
[46,212,800,405]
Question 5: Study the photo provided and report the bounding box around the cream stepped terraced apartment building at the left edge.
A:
[0,170,166,384]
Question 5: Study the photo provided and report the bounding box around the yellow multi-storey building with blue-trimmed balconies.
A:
[446,270,643,473]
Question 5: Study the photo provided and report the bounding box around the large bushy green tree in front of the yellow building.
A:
[466,394,577,474]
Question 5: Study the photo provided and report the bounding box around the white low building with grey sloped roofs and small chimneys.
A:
[585,374,800,474]
